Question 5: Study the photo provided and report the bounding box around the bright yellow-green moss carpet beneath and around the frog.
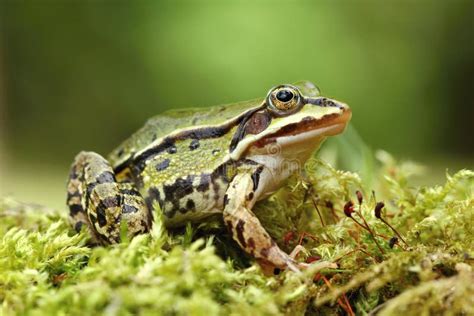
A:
[0,152,474,315]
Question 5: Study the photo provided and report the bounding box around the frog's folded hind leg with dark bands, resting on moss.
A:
[67,152,151,244]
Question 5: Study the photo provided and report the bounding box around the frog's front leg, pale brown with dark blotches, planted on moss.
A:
[224,173,302,271]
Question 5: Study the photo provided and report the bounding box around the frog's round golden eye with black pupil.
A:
[267,85,301,116]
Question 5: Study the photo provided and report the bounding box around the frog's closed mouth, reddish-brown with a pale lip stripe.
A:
[252,108,352,148]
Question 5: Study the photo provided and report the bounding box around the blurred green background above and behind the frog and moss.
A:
[0,0,474,207]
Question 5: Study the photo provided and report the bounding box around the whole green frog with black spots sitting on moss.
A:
[67,81,352,271]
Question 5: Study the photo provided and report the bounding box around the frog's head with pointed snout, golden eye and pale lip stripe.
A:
[231,81,351,160]
